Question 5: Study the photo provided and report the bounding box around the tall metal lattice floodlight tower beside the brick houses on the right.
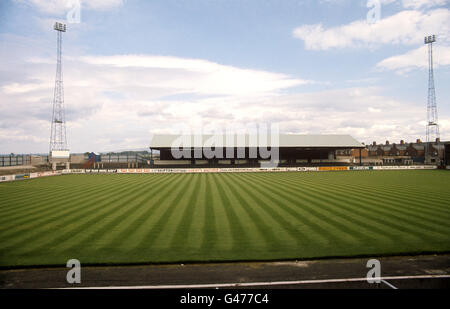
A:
[425,35,440,161]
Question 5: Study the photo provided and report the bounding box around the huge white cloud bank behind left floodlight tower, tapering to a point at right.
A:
[0,55,309,152]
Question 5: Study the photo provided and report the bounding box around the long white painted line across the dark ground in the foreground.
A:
[59,275,450,289]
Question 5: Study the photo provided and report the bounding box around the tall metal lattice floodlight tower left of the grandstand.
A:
[50,22,68,155]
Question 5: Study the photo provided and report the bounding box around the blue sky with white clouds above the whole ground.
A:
[0,0,450,154]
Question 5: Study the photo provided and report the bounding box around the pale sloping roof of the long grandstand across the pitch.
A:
[150,134,365,149]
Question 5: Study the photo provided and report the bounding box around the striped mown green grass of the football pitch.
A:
[0,171,450,267]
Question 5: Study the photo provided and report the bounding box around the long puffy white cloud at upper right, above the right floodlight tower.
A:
[293,9,450,50]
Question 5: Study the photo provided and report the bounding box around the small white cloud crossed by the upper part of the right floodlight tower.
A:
[376,45,450,73]
